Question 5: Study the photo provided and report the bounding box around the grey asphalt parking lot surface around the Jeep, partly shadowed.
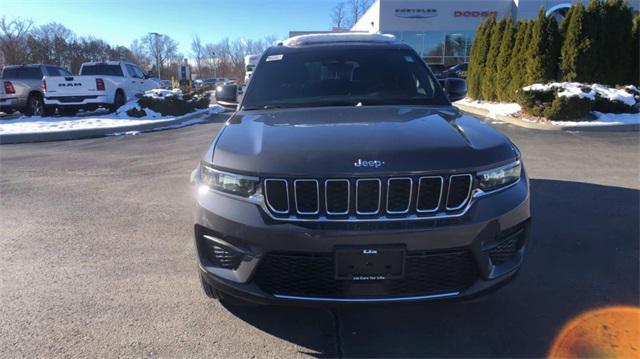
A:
[0,114,640,358]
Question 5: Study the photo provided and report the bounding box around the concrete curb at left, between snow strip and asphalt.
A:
[0,112,229,145]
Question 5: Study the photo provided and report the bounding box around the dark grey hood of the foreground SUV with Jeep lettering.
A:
[208,106,517,177]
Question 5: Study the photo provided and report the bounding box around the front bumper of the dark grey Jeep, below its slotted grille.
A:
[195,171,530,304]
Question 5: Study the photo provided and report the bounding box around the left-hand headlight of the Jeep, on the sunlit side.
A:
[200,163,260,197]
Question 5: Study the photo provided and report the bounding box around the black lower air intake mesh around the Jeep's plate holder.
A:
[254,250,478,298]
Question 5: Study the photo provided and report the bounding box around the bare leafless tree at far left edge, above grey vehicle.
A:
[0,16,33,64]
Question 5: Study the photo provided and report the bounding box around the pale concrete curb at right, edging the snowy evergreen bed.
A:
[453,103,640,132]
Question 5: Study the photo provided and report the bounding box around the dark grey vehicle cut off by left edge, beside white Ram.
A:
[0,65,73,116]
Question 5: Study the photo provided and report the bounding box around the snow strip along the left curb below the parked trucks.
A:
[0,101,224,135]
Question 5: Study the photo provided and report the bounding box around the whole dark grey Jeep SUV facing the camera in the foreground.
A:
[192,34,530,304]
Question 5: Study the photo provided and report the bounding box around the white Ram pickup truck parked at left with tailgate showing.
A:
[42,61,159,114]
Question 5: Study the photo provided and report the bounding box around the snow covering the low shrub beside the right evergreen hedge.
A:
[522,82,637,106]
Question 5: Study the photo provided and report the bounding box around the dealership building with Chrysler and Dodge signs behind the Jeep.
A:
[302,0,634,66]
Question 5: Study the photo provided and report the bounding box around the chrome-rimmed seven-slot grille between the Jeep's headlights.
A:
[264,174,473,219]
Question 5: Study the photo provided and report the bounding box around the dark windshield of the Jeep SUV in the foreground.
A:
[243,47,448,110]
